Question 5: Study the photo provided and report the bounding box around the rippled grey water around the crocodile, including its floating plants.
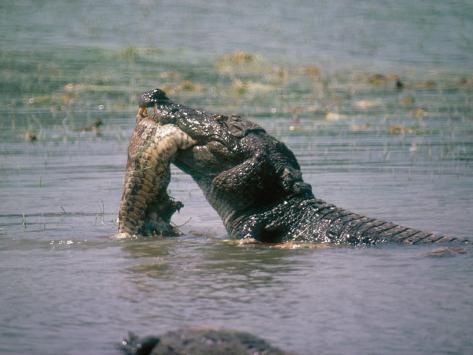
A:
[0,0,473,354]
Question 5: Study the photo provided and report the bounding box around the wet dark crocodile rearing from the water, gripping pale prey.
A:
[122,89,468,244]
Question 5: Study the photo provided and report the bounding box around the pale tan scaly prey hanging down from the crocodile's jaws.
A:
[117,116,195,237]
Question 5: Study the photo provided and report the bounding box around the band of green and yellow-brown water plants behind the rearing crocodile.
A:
[0,47,473,149]
